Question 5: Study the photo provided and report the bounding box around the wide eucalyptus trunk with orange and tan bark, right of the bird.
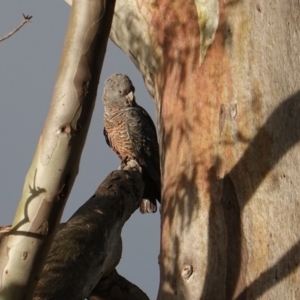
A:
[110,0,300,300]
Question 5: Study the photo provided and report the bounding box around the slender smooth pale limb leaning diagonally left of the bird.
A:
[0,0,114,300]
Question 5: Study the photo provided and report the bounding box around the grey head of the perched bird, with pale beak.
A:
[102,74,136,110]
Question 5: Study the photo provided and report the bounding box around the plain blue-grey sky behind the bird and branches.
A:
[0,0,160,299]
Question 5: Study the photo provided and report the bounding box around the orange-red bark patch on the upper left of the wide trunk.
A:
[152,0,232,223]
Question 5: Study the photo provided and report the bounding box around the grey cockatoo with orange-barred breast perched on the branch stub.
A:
[102,74,161,213]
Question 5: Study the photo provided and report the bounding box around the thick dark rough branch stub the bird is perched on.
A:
[34,163,147,300]
